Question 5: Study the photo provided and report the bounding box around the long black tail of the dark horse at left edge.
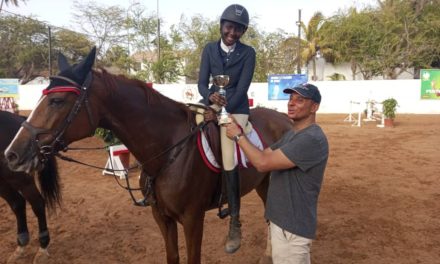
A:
[38,157,61,210]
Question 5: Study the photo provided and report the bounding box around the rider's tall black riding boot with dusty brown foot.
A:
[225,167,241,254]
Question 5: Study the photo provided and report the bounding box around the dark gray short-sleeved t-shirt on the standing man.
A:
[265,124,329,239]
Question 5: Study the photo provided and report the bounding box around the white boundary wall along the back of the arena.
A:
[18,80,440,114]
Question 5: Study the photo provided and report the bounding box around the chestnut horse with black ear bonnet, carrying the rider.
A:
[6,46,291,263]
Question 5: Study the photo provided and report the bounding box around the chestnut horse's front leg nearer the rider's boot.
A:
[182,211,205,264]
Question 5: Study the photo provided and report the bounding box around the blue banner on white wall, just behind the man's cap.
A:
[267,74,308,100]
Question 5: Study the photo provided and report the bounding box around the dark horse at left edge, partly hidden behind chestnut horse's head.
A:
[0,111,61,261]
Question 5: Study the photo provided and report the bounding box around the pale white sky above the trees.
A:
[3,0,377,34]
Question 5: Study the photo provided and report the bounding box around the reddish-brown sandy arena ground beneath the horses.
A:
[0,114,440,264]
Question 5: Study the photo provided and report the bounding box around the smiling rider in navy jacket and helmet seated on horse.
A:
[198,4,255,253]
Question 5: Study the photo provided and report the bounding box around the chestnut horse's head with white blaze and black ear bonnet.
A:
[5,48,97,172]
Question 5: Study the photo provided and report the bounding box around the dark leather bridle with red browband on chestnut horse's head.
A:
[21,71,95,163]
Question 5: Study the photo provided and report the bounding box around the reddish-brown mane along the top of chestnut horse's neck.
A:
[93,68,195,126]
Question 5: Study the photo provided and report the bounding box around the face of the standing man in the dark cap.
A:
[287,92,319,121]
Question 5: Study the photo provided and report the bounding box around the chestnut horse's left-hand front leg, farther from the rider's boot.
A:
[152,207,179,264]
